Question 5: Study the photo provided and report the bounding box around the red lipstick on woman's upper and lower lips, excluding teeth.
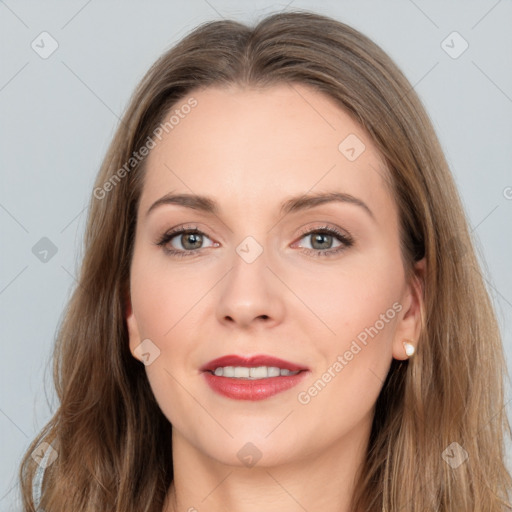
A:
[200,355,308,400]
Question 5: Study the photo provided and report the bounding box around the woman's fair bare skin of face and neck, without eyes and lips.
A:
[126,84,425,512]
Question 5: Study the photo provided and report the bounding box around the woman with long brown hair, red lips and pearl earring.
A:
[20,9,511,512]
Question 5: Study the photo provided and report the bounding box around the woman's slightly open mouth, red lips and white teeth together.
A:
[200,355,309,400]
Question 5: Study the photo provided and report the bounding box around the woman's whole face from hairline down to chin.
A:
[127,85,420,465]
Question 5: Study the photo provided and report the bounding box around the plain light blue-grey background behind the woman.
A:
[0,0,512,511]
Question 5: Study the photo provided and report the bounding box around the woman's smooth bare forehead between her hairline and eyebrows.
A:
[140,84,393,221]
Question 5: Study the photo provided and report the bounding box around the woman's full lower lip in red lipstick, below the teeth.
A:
[203,371,308,401]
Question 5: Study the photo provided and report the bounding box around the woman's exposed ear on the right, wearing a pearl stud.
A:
[393,258,426,360]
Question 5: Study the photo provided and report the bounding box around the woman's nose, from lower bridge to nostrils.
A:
[217,245,285,328]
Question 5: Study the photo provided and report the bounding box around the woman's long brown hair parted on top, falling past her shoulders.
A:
[20,12,512,512]
